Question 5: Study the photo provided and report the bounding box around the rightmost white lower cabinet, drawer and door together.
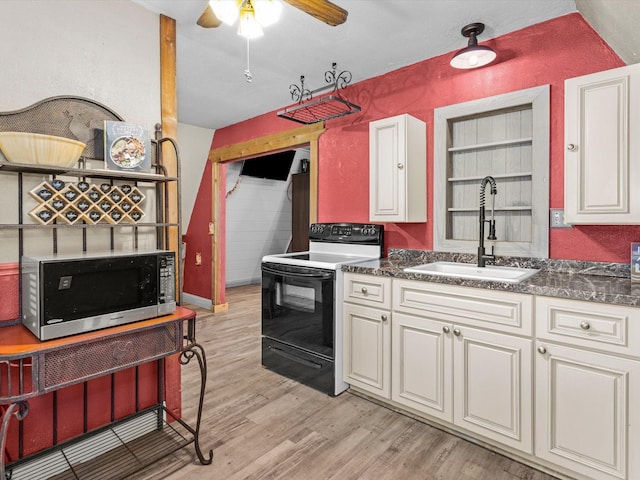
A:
[535,297,640,480]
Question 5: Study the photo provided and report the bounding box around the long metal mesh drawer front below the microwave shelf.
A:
[39,322,182,392]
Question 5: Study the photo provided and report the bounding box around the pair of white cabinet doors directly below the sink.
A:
[391,312,533,453]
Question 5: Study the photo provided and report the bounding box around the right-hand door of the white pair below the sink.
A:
[453,326,533,453]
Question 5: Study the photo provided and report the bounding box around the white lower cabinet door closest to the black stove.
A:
[343,303,391,399]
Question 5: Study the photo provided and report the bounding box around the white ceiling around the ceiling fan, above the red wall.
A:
[131,0,580,129]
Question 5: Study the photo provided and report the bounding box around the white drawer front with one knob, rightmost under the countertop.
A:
[536,297,640,356]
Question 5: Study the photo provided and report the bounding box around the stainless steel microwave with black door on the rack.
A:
[22,250,176,340]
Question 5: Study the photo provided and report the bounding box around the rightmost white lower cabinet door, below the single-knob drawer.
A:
[535,343,640,480]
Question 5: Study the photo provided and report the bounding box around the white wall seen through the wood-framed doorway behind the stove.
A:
[226,149,309,287]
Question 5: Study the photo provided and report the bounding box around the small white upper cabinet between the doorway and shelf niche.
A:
[369,114,427,222]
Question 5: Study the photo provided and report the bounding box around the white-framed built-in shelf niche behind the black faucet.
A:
[434,87,549,257]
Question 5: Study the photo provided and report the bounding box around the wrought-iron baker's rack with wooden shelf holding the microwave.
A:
[0,96,213,480]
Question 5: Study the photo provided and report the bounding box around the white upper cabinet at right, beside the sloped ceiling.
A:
[564,64,640,225]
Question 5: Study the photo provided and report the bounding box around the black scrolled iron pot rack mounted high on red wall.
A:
[278,62,361,125]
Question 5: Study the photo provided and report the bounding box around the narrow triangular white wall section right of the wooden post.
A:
[177,123,215,234]
